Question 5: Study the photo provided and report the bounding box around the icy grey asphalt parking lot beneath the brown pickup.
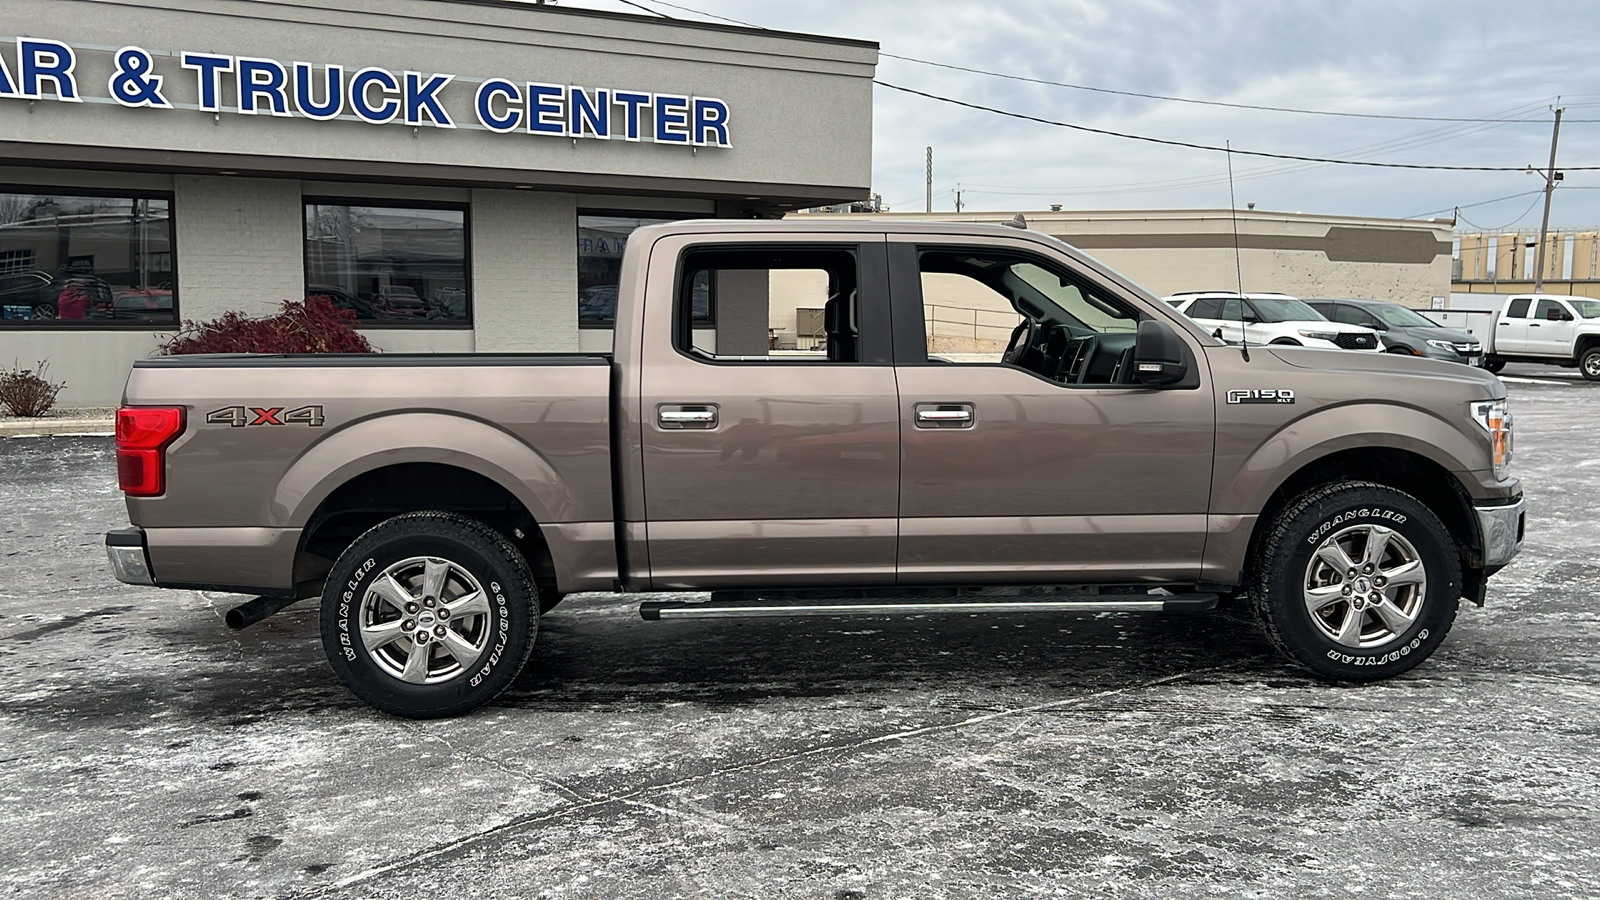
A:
[0,360,1600,900]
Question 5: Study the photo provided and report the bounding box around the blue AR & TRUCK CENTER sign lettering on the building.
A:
[0,37,733,147]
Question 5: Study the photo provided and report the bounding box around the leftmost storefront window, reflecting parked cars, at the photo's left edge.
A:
[0,191,178,328]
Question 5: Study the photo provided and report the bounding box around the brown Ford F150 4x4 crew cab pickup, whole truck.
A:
[106,216,1525,716]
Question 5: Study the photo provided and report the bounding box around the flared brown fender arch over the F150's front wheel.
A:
[1211,402,1490,516]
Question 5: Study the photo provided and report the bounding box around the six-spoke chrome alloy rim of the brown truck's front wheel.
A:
[1302,525,1427,647]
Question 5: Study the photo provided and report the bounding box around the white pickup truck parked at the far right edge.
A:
[1483,293,1600,381]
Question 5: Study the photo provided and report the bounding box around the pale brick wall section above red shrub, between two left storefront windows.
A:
[173,175,306,320]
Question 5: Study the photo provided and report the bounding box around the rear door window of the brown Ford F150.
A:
[674,245,861,364]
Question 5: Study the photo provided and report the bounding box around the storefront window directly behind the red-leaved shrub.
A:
[306,200,470,328]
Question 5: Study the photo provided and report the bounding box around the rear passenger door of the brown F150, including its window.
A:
[619,234,899,589]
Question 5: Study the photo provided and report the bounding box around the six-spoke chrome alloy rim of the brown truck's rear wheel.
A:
[358,556,490,684]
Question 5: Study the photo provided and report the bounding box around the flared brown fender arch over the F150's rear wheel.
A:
[267,412,578,527]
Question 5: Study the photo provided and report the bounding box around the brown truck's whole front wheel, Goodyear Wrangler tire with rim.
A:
[1250,482,1461,681]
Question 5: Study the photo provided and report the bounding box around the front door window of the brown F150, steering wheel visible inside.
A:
[918,248,1139,384]
